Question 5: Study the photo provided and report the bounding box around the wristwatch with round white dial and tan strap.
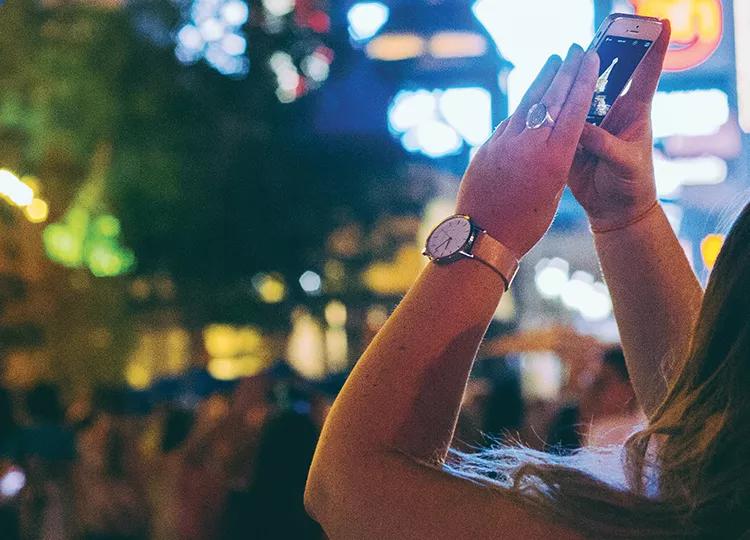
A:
[422,215,518,291]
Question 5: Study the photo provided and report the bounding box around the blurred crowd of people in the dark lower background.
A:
[0,328,644,540]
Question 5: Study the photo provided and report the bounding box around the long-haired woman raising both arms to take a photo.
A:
[306,21,750,539]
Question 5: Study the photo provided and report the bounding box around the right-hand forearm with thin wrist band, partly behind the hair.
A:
[594,208,703,415]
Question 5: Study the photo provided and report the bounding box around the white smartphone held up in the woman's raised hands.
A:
[586,13,662,126]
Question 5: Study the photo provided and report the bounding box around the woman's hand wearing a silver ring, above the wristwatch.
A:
[457,45,599,258]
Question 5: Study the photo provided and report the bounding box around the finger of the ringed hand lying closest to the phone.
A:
[550,51,599,143]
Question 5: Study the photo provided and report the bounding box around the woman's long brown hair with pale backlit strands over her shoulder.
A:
[445,204,750,539]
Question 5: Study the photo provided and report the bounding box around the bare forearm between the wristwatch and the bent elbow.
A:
[312,260,503,479]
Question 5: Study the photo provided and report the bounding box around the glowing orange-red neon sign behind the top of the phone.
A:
[630,0,724,71]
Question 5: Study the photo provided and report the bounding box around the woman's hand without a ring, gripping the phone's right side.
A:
[568,20,670,230]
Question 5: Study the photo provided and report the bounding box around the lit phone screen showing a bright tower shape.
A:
[586,36,653,126]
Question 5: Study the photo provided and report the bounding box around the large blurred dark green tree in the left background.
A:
[0,0,416,392]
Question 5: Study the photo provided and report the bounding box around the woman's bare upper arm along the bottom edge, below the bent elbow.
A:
[316,455,583,540]
